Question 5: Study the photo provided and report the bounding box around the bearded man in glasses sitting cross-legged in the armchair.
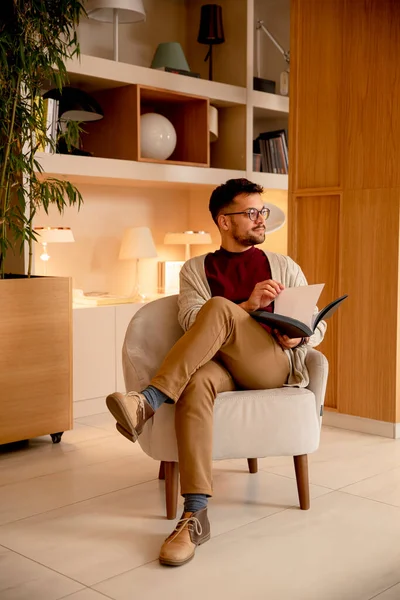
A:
[107,179,326,566]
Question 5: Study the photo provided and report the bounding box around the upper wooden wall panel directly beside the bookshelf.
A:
[289,0,343,191]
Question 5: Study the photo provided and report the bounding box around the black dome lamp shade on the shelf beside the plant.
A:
[43,87,104,121]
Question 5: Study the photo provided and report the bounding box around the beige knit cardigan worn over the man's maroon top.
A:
[178,252,326,387]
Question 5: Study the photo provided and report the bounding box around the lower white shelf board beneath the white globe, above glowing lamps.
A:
[36,152,247,187]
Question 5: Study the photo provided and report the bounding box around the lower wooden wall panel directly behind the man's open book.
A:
[293,195,340,408]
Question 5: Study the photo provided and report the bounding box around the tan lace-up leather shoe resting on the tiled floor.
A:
[160,508,211,567]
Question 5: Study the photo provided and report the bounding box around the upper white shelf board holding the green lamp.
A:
[66,55,246,106]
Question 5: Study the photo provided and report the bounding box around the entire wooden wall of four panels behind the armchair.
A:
[289,0,400,431]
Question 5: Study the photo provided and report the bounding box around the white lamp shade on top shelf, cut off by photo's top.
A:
[85,0,146,23]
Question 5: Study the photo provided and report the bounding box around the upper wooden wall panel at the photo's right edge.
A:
[342,0,400,189]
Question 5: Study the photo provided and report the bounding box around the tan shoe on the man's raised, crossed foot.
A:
[106,392,154,442]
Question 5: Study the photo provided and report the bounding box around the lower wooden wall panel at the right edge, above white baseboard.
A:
[338,190,399,422]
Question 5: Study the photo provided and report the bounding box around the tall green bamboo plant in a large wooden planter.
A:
[0,0,84,444]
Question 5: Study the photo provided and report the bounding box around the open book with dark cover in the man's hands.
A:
[250,283,347,338]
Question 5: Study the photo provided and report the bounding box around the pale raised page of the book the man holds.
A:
[274,283,325,329]
